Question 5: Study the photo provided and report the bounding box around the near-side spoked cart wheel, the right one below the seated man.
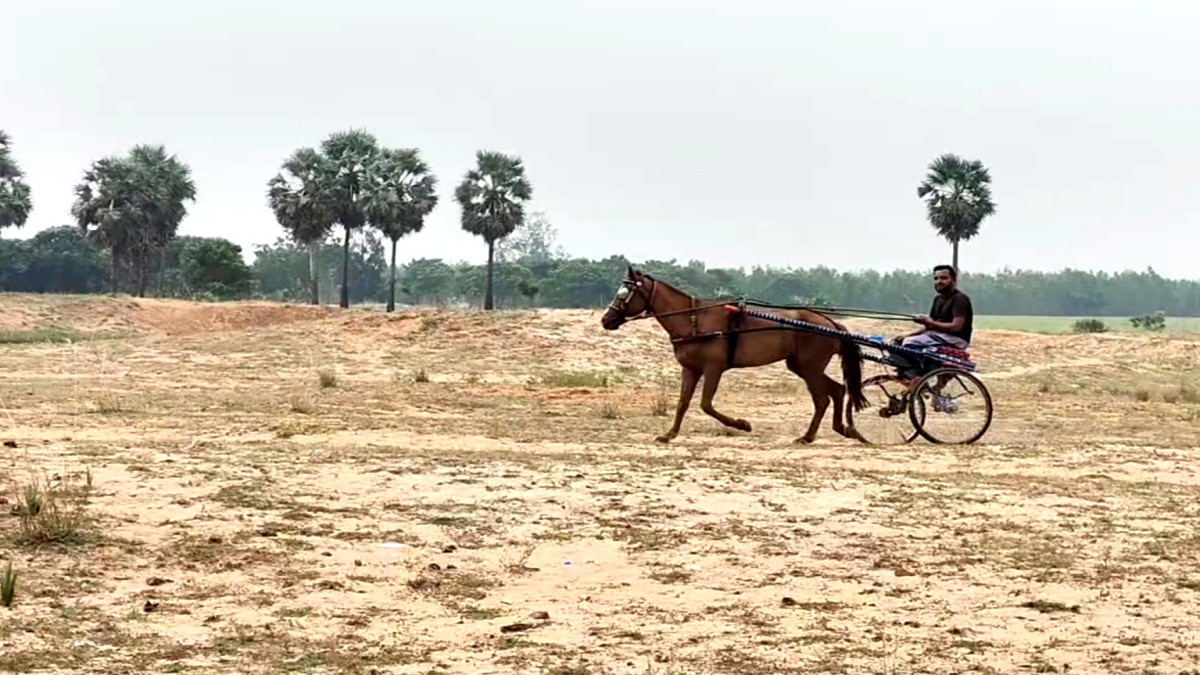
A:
[908,368,992,446]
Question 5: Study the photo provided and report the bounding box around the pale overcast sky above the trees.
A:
[0,0,1200,279]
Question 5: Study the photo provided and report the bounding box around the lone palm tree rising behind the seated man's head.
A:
[917,154,996,270]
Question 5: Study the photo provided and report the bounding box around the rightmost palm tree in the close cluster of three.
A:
[365,148,438,312]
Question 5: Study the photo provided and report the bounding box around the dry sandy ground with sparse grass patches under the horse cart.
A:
[0,295,1200,675]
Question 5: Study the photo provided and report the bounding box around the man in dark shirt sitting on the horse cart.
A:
[888,264,974,381]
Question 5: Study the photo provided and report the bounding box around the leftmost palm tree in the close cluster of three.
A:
[266,148,336,305]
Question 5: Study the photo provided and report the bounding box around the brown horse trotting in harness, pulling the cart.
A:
[600,267,866,443]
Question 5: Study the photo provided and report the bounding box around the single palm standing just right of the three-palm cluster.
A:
[455,150,533,310]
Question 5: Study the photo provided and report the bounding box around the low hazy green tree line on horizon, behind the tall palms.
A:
[0,220,1200,317]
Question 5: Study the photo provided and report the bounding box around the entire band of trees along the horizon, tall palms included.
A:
[0,130,1200,316]
